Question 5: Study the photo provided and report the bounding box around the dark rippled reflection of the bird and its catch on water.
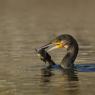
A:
[41,62,78,82]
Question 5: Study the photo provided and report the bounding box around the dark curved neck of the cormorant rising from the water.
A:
[61,43,78,68]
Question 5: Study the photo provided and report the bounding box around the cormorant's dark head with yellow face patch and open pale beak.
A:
[37,34,74,51]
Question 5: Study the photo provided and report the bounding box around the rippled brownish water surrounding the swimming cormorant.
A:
[0,0,95,95]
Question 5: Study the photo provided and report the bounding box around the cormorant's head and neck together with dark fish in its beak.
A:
[36,34,79,69]
